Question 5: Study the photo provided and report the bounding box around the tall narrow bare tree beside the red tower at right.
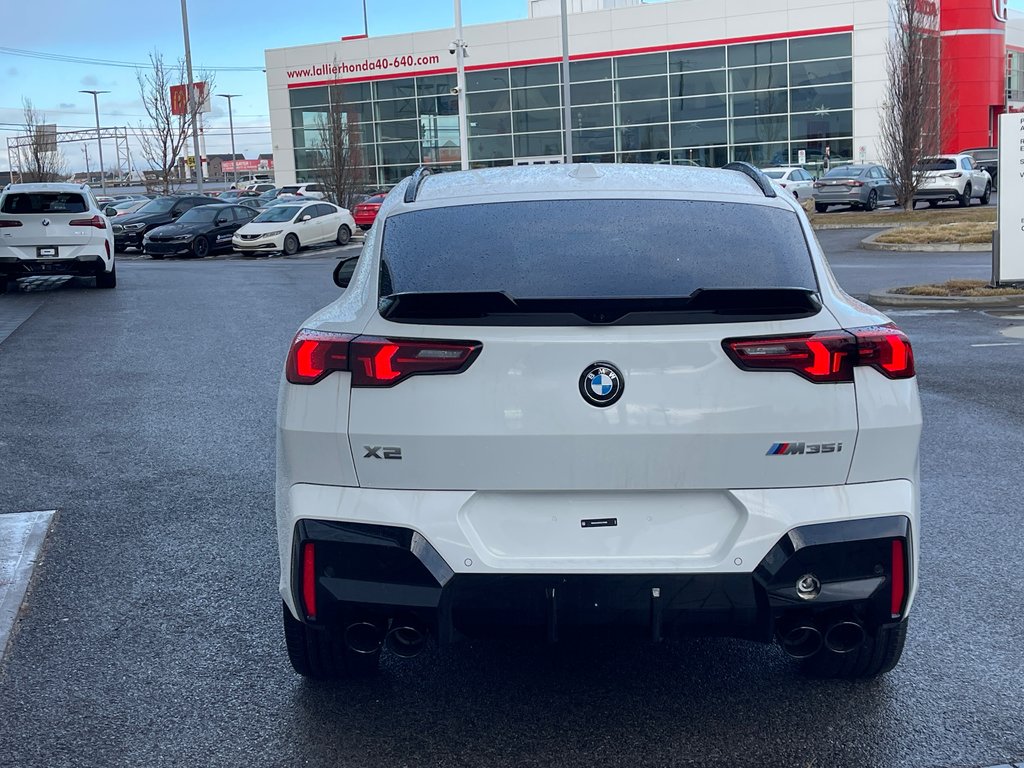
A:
[880,0,943,210]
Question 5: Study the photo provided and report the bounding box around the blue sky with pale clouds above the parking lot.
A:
[0,0,1024,170]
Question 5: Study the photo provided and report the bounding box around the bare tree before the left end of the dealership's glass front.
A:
[309,97,366,208]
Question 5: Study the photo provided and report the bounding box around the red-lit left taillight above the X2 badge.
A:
[285,330,482,387]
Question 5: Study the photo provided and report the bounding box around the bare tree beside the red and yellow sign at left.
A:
[135,51,213,195]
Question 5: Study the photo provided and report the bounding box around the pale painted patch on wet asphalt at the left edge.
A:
[0,509,56,658]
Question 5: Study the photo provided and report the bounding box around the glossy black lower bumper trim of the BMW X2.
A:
[289,516,912,643]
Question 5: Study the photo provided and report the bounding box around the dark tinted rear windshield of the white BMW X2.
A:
[380,200,817,299]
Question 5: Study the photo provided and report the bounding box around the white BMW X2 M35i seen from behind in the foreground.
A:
[276,163,921,678]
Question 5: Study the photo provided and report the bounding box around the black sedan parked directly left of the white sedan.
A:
[142,205,257,259]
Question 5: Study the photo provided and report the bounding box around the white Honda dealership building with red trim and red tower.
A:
[266,0,1024,187]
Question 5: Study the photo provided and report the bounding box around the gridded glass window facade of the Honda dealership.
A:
[291,33,853,187]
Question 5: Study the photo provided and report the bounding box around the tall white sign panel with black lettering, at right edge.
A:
[992,112,1024,285]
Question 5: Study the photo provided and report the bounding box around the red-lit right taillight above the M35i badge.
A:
[722,326,914,384]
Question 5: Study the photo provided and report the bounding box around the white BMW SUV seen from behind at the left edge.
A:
[0,183,117,293]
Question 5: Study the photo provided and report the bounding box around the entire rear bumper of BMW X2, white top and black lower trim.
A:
[278,480,919,641]
